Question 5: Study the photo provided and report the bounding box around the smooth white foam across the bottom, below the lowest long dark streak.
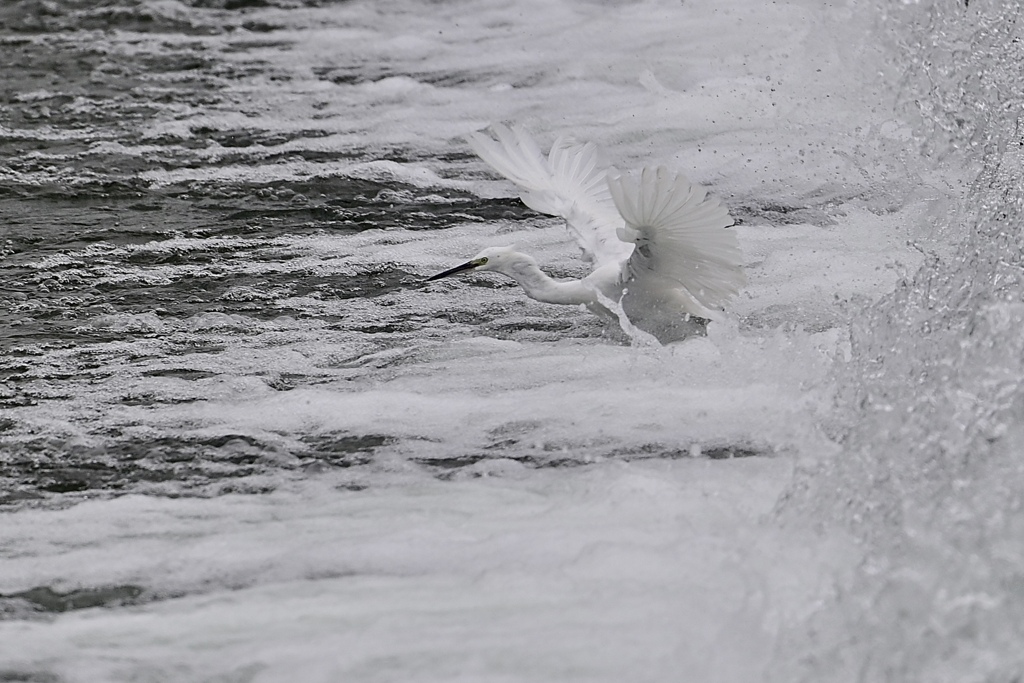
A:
[0,461,798,681]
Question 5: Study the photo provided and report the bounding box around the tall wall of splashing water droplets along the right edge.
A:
[774,0,1024,681]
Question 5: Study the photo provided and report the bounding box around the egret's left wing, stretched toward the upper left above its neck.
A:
[466,124,632,267]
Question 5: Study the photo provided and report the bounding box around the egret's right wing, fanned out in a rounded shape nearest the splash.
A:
[608,167,746,314]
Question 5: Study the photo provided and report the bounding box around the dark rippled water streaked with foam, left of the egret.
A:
[0,0,569,503]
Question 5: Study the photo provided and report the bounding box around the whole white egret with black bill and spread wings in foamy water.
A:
[428,125,745,344]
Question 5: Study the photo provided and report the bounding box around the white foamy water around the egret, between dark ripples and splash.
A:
[0,0,962,683]
